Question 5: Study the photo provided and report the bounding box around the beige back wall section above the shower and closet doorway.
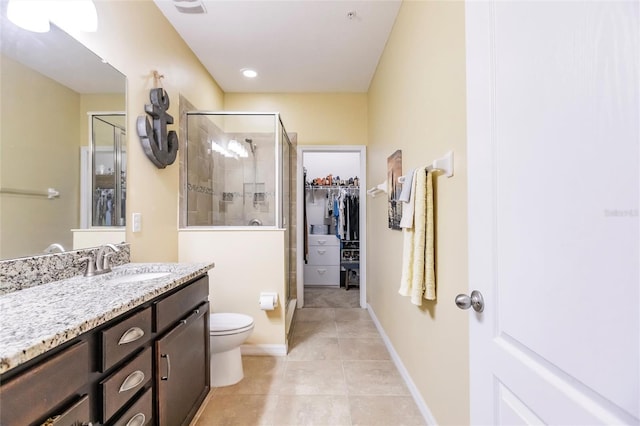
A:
[224,93,367,145]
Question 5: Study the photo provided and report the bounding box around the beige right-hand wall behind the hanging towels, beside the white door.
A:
[367,1,469,425]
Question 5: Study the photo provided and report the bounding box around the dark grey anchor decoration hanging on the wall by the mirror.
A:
[136,87,178,169]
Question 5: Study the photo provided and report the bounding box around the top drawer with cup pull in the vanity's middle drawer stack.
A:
[100,308,151,372]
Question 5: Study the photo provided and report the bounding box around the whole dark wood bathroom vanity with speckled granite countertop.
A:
[0,263,213,426]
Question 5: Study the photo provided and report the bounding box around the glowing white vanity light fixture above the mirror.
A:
[7,0,98,33]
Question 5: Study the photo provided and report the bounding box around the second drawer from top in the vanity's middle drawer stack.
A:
[100,348,152,423]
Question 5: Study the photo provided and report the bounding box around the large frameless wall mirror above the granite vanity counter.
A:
[0,4,126,259]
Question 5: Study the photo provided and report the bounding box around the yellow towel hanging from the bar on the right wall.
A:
[398,167,436,306]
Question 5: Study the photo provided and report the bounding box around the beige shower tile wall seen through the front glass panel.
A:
[180,105,277,227]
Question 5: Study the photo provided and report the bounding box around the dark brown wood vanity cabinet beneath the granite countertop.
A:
[0,275,210,426]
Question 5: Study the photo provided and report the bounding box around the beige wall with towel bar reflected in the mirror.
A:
[0,56,81,258]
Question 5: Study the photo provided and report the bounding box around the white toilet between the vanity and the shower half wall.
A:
[209,313,253,387]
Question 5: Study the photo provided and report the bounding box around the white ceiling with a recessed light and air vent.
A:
[154,0,401,93]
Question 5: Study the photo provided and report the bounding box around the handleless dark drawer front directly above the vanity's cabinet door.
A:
[155,275,209,332]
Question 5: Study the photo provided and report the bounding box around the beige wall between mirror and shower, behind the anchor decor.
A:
[73,0,223,262]
